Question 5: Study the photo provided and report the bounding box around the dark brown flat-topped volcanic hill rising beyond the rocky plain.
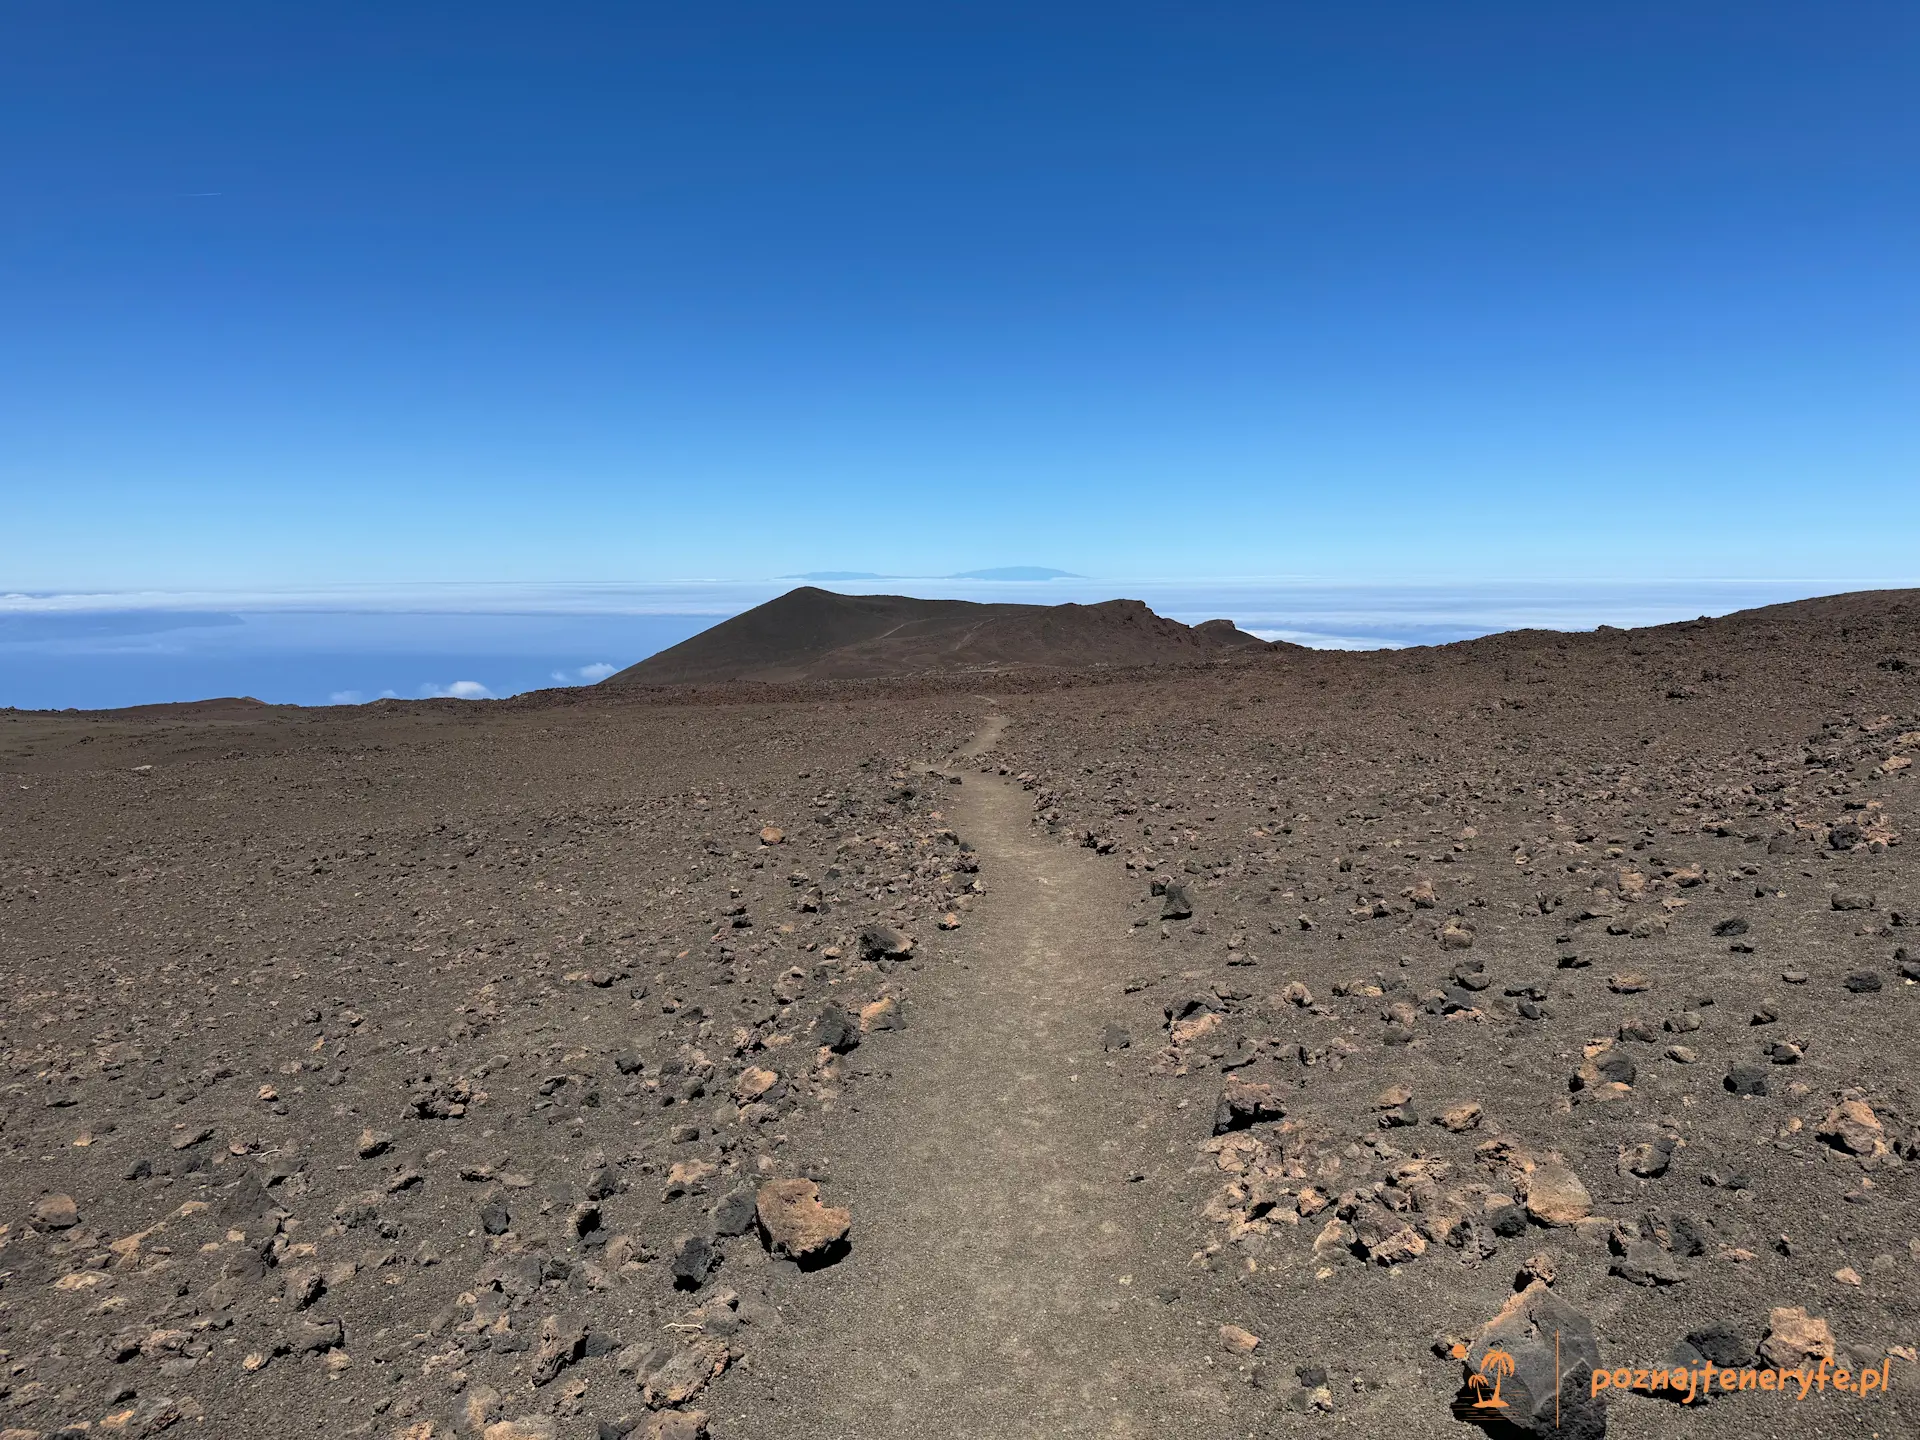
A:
[603,586,1273,687]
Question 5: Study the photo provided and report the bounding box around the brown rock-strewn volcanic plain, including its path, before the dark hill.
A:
[0,591,1920,1440]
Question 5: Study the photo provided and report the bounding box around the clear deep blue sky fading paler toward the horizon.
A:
[0,0,1920,589]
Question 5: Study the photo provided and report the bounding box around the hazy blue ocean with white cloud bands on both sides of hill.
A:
[0,578,1889,708]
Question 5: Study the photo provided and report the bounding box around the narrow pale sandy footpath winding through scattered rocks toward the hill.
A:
[728,716,1227,1440]
